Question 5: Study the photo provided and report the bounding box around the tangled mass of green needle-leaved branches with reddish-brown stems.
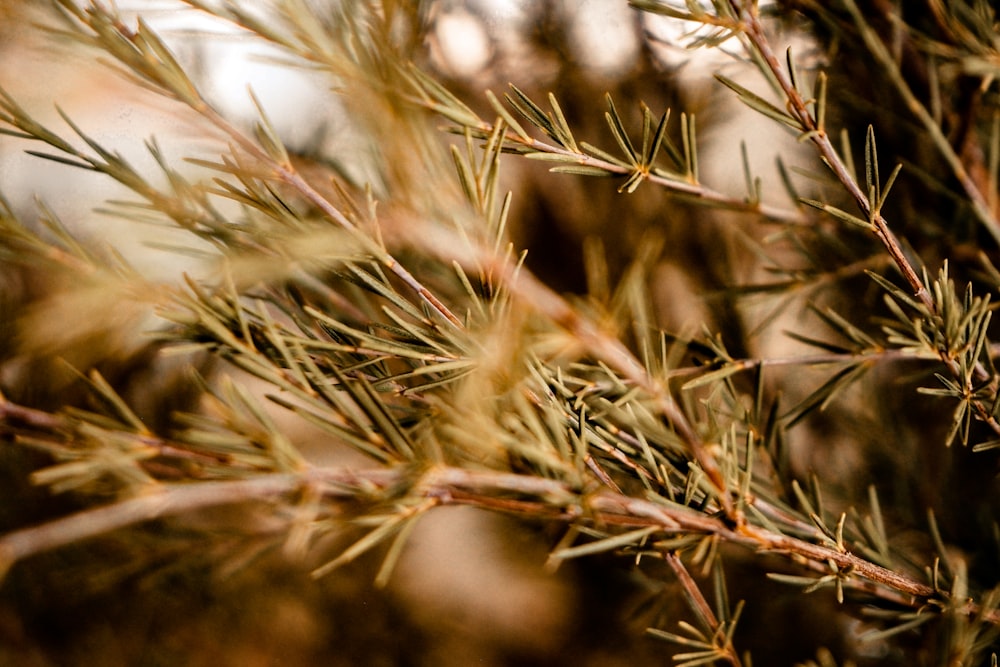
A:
[0,0,1000,667]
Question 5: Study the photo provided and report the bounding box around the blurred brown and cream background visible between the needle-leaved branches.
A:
[0,0,993,667]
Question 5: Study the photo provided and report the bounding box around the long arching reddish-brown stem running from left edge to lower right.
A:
[0,466,980,624]
